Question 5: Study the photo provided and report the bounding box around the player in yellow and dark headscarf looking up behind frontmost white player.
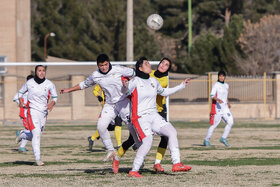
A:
[112,57,171,173]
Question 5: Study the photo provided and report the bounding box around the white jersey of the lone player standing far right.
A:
[211,82,229,113]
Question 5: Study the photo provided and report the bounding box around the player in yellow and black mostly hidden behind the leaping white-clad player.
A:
[88,84,122,151]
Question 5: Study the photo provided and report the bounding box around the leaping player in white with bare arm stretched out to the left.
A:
[60,54,139,162]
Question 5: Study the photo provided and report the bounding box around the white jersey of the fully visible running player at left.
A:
[19,79,57,113]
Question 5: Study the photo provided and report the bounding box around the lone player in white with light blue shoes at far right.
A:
[203,71,233,147]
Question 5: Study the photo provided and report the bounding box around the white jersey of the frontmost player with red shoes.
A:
[127,77,185,116]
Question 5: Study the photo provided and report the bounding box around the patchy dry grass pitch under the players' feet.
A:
[0,121,280,186]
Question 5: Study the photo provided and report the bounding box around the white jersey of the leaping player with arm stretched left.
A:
[79,66,134,104]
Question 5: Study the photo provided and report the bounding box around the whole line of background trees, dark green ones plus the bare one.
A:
[31,0,280,75]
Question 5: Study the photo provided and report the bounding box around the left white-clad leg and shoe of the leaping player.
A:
[97,104,116,162]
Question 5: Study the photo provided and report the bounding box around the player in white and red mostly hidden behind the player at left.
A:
[13,75,34,153]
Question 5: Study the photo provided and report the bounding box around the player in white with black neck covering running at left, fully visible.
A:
[19,65,57,166]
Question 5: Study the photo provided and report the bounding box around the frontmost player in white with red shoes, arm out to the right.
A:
[123,57,191,177]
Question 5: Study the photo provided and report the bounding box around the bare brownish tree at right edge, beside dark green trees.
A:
[235,15,280,75]
